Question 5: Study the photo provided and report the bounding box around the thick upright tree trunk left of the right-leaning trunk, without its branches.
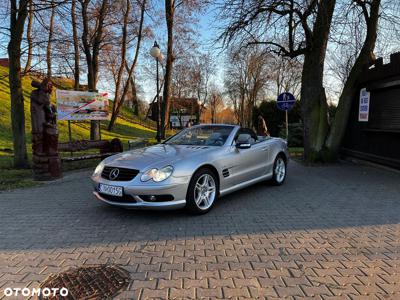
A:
[301,0,336,162]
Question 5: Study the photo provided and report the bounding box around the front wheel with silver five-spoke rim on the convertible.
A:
[186,168,219,215]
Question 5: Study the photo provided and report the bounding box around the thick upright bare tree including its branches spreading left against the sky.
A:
[220,0,336,161]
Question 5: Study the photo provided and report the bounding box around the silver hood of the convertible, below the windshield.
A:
[104,144,219,172]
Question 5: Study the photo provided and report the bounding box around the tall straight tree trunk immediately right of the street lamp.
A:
[161,0,175,139]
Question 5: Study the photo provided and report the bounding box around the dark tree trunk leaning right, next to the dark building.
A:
[325,0,381,161]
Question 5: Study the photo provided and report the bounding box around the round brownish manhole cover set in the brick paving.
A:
[39,265,130,300]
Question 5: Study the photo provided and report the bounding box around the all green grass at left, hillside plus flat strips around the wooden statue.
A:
[0,66,155,190]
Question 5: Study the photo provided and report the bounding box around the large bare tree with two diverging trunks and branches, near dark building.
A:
[220,0,396,161]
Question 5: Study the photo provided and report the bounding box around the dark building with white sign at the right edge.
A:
[342,53,400,169]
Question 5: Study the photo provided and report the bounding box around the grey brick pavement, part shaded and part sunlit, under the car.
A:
[0,162,400,300]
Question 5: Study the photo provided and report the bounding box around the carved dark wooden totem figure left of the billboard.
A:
[31,79,62,180]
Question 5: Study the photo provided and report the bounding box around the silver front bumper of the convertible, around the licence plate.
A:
[92,176,188,210]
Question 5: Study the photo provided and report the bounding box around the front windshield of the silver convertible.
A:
[165,125,234,146]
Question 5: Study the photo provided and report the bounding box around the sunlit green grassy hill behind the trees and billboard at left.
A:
[0,66,155,168]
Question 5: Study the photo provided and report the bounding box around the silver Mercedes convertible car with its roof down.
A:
[92,124,289,214]
